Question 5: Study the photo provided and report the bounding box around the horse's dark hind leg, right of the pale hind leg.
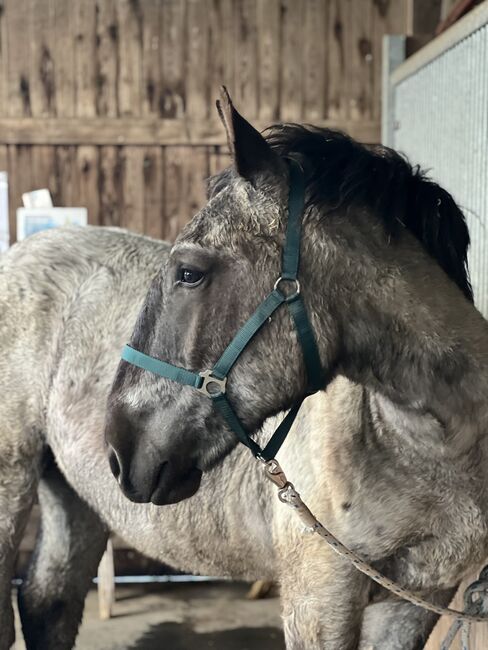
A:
[19,463,107,650]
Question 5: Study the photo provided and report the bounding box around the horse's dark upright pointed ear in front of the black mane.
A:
[217,86,283,181]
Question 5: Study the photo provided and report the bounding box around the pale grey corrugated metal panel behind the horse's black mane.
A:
[391,7,488,316]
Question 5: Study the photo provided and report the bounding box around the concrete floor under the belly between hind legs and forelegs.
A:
[14,582,285,650]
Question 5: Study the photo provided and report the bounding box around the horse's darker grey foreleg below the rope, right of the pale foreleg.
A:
[360,589,456,650]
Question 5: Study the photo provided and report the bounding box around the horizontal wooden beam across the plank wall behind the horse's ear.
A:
[0,117,380,146]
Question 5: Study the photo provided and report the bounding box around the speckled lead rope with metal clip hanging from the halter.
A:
[261,458,488,650]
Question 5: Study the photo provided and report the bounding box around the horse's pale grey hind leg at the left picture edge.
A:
[0,434,41,650]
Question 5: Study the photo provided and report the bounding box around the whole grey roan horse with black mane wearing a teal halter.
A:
[0,95,488,650]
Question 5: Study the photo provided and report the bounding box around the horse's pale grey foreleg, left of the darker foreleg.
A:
[279,534,369,650]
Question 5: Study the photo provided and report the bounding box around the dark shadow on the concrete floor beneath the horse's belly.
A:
[127,623,285,650]
